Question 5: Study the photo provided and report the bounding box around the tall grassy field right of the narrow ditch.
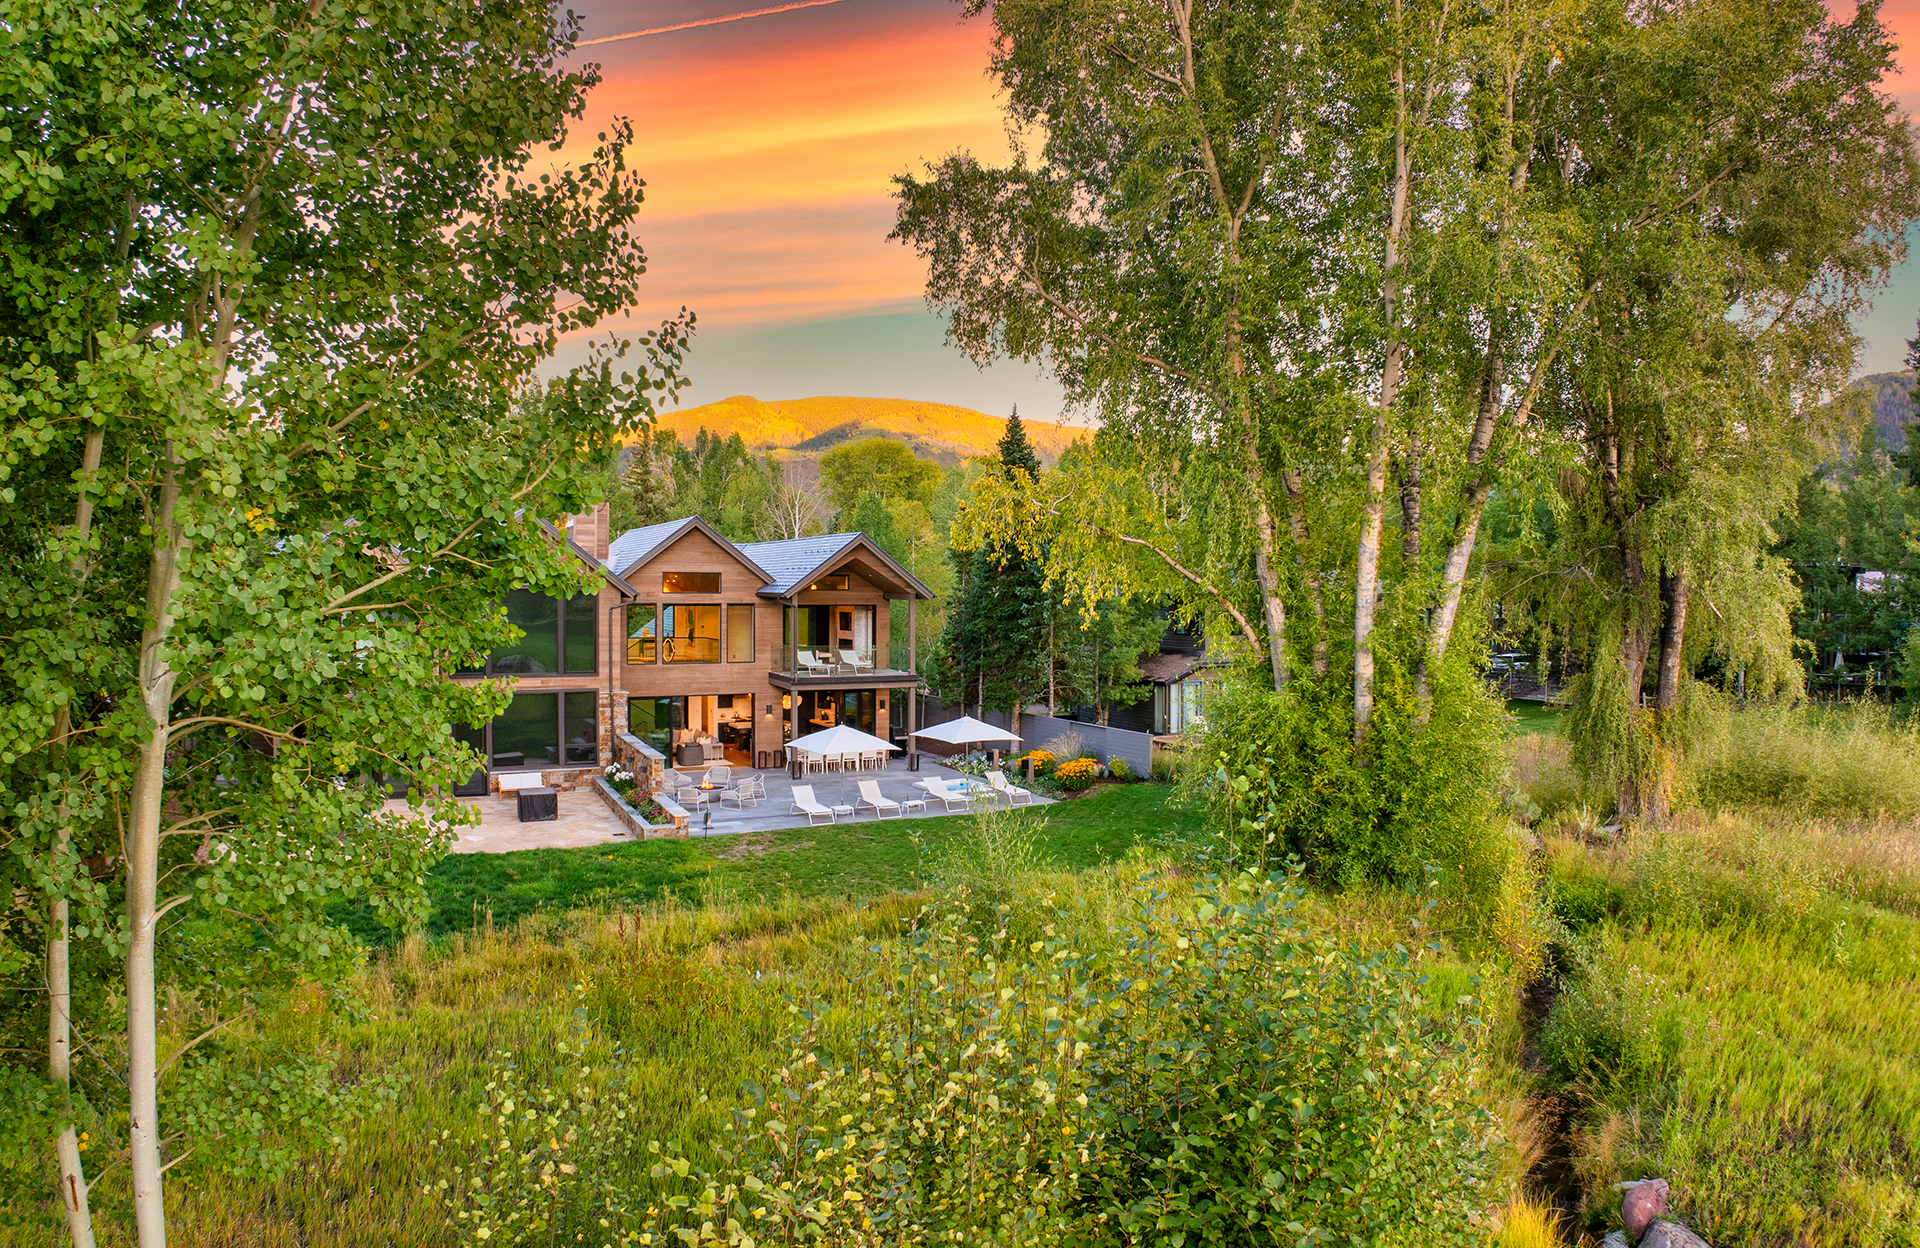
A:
[1517,698,1920,1248]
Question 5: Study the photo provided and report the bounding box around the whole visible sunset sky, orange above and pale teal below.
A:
[563,0,1920,419]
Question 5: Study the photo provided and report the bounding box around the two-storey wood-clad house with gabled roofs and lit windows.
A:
[455,505,933,791]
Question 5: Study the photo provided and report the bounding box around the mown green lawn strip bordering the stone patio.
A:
[338,771,1200,943]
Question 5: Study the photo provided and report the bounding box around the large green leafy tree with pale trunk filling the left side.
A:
[0,0,684,1248]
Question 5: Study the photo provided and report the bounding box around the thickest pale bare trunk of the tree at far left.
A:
[123,472,182,1248]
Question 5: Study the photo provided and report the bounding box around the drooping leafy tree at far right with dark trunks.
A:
[1505,0,1920,820]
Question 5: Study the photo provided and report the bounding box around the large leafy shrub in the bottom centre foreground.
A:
[622,876,1494,1248]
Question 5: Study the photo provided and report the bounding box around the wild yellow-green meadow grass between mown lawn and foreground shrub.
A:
[26,821,1521,1248]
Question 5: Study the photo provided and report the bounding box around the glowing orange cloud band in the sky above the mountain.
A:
[533,0,1008,328]
